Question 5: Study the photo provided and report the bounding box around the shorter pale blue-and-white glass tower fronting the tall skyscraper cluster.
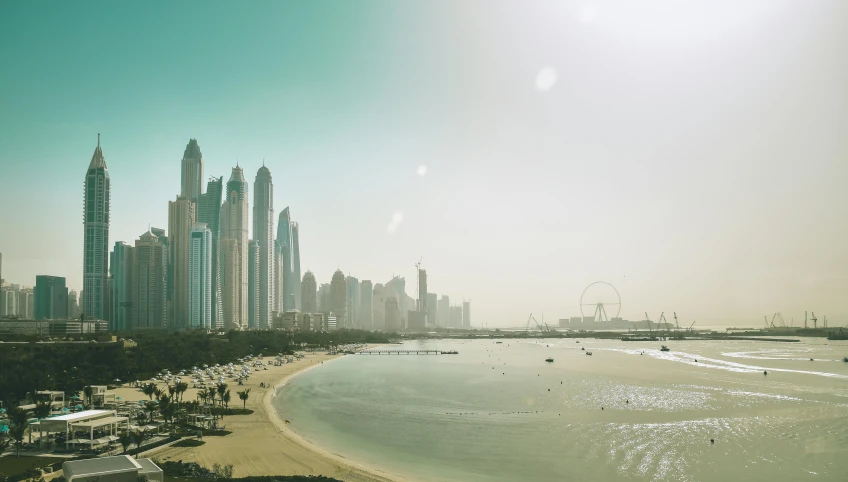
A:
[188,223,213,330]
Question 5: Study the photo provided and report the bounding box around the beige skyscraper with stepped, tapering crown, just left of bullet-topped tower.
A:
[220,166,249,330]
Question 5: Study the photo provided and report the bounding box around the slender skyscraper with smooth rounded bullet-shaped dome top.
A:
[253,165,276,328]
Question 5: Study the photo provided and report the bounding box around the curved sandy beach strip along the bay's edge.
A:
[116,353,401,482]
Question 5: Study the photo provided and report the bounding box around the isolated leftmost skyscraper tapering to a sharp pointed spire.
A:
[82,134,110,320]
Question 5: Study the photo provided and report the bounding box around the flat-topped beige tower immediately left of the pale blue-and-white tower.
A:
[168,197,197,330]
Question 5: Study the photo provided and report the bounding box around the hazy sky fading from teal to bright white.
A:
[0,0,848,327]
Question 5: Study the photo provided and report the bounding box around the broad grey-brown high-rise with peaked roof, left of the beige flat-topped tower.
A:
[129,229,168,329]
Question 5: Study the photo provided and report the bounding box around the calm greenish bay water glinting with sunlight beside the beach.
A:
[274,339,848,482]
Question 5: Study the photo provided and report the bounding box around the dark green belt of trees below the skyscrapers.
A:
[0,330,388,406]
